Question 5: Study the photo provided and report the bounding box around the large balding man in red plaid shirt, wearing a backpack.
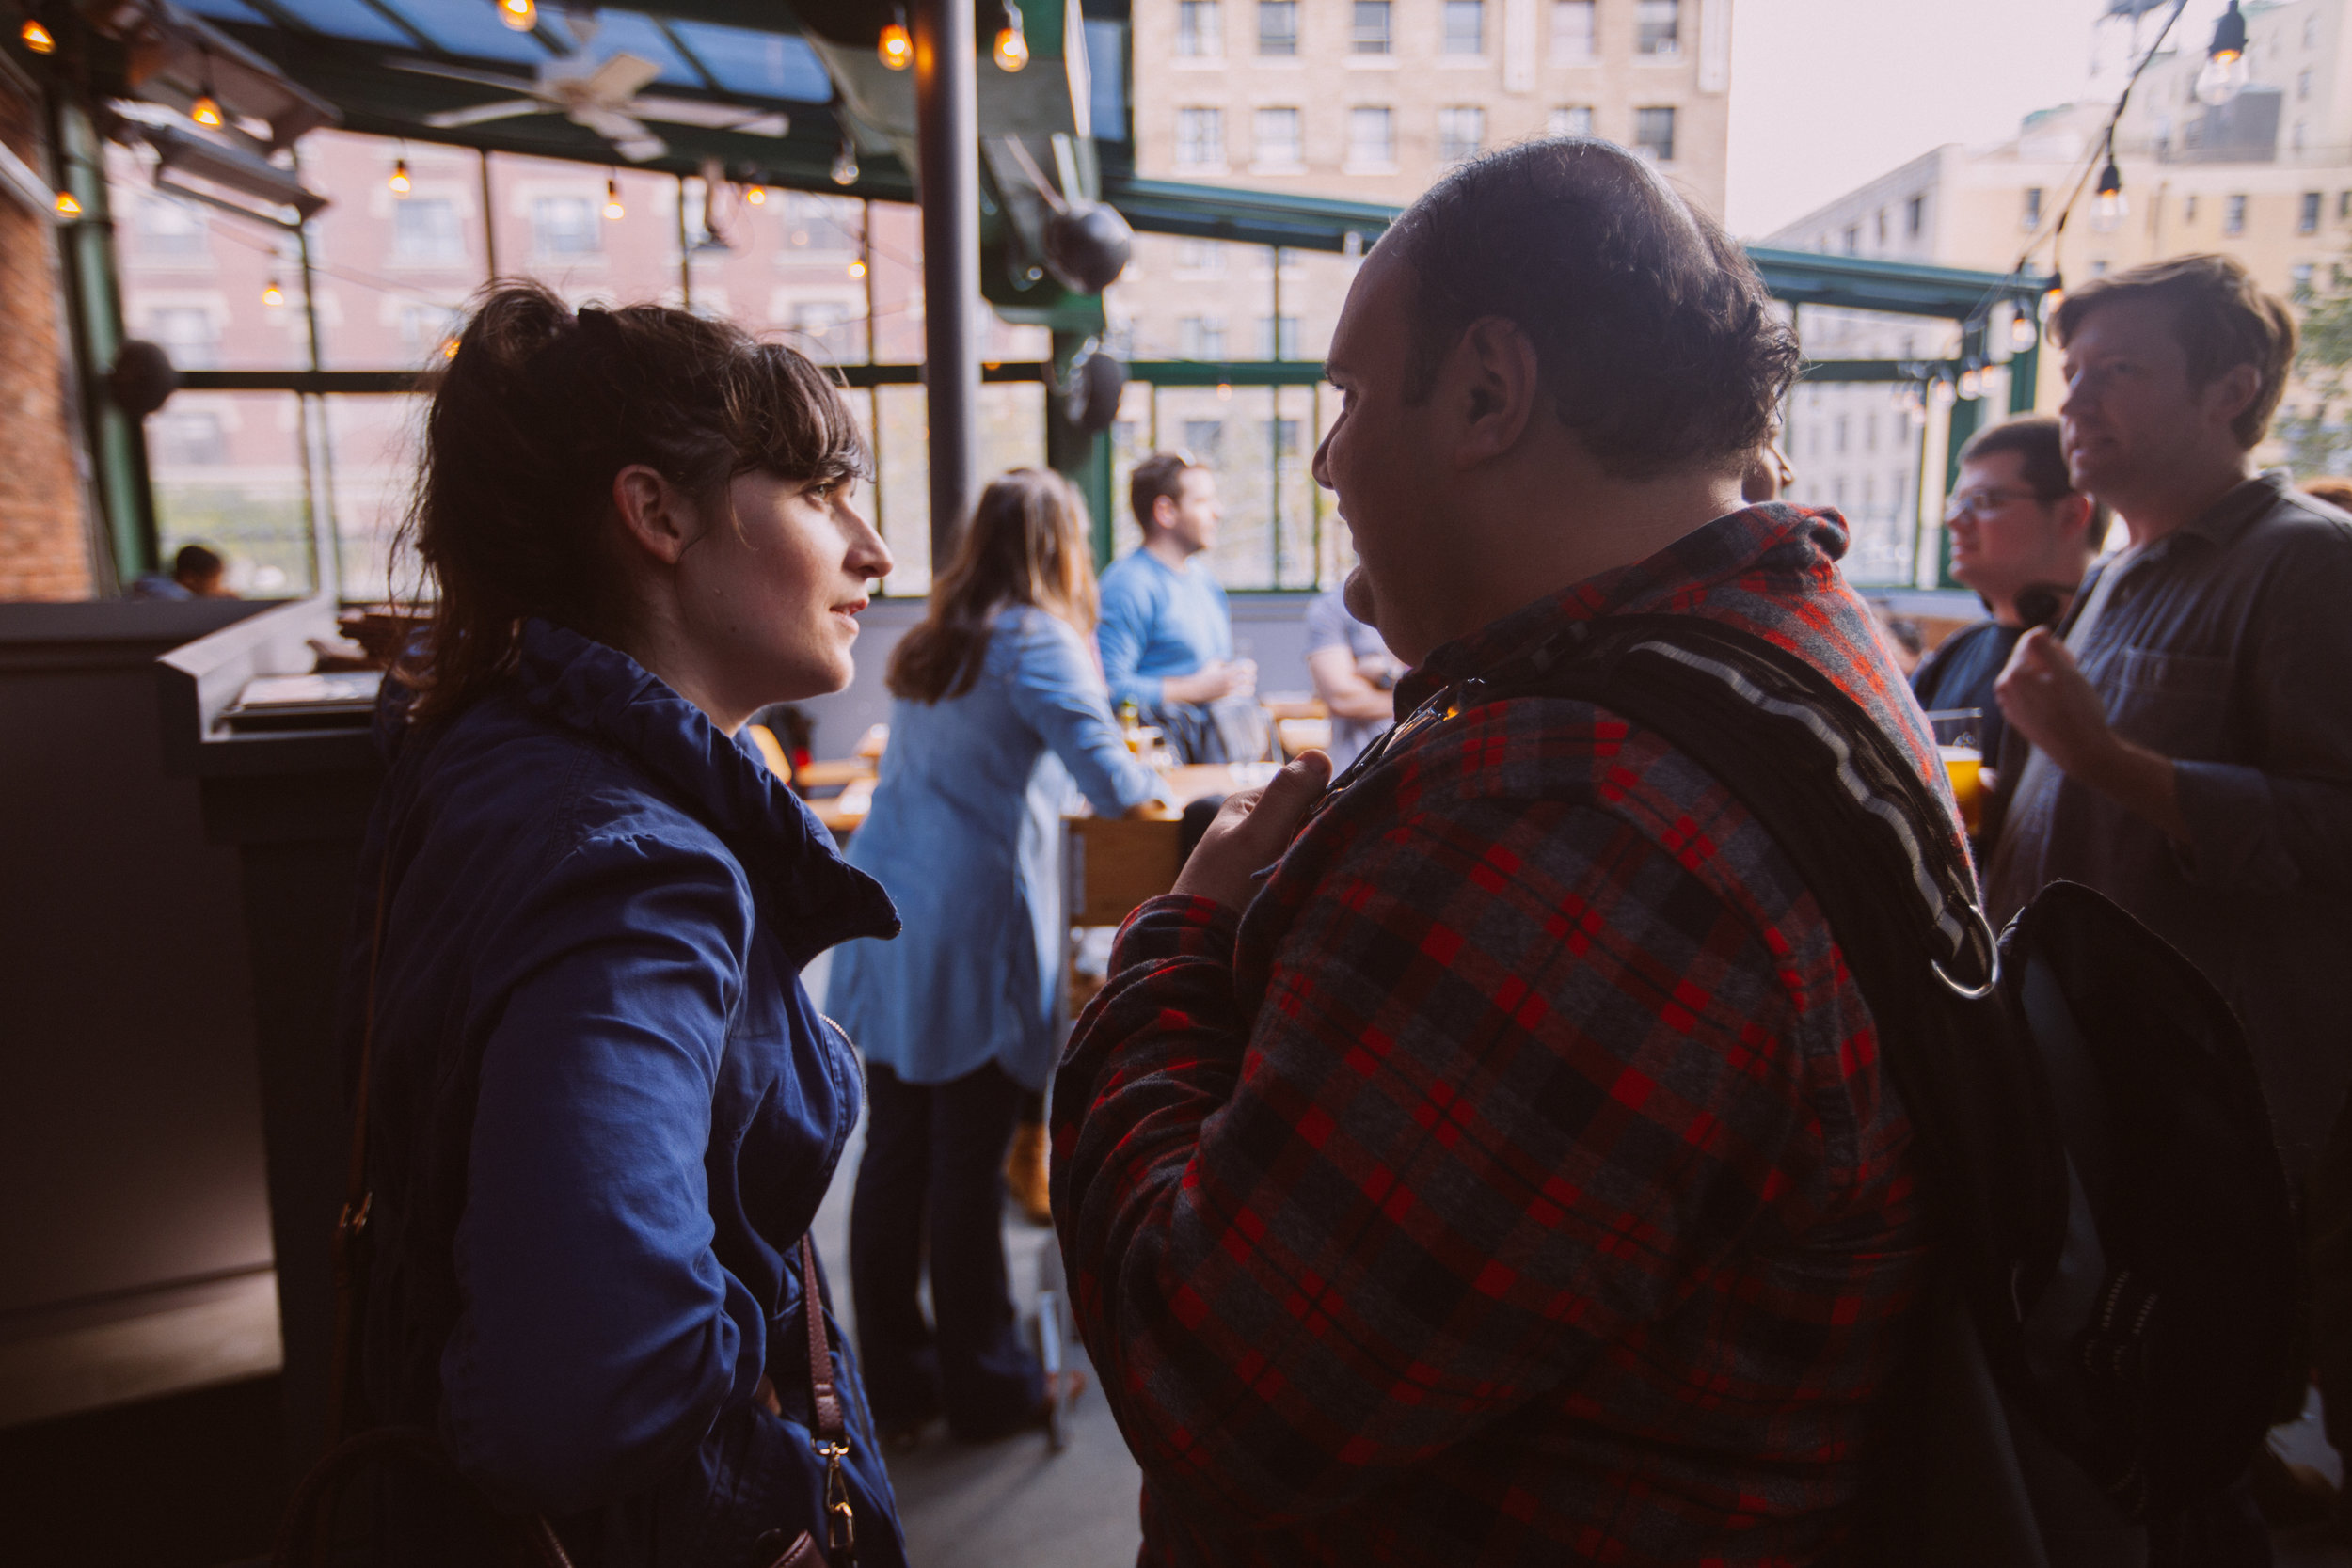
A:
[1054,141,1960,1566]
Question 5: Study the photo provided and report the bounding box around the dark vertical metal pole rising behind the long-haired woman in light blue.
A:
[915,0,981,571]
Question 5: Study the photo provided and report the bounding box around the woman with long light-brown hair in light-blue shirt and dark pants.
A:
[826,467,1157,1441]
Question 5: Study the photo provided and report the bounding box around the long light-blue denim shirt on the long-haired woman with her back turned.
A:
[826,607,1160,1088]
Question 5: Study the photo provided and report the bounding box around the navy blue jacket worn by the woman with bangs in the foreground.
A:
[342,621,903,1568]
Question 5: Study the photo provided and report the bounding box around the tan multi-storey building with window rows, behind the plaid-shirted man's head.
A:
[1105,0,1731,588]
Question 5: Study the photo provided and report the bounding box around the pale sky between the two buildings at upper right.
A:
[1724,0,2223,237]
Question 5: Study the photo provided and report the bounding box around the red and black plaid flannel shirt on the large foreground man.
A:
[1054,505,1960,1568]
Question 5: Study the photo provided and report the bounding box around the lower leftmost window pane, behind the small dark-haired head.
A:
[149,392,313,599]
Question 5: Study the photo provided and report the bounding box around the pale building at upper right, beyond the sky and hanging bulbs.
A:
[1764,0,2352,580]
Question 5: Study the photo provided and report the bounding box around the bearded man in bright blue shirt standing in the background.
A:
[1094,451,1259,762]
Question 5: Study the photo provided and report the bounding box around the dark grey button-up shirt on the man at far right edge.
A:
[1985,470,2352,1176]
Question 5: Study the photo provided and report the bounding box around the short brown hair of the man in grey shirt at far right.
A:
[2051,256,2296,449]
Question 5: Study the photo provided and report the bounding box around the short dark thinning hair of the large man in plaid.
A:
[1381,136,1800,480]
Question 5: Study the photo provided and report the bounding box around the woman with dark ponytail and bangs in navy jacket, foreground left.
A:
[342,284,903,1568]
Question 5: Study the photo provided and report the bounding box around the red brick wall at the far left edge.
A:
[0,80,94,599]
